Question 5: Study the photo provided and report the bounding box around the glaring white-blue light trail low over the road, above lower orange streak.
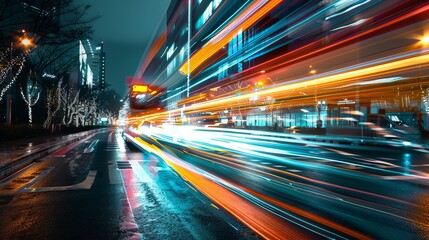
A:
[146,127,427,205]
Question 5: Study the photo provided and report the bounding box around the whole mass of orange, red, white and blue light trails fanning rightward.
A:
[124,0,429,239]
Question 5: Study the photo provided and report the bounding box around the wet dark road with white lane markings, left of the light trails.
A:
[0,131,259,239]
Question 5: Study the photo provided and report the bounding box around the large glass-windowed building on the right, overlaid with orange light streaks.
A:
[139,0,429,131]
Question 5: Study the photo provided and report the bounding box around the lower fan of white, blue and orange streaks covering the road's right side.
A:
[124,126,429,239]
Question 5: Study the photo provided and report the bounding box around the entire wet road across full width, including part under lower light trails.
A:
[0,126,429,239]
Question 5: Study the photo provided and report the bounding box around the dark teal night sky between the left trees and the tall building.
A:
[77,0,170,96]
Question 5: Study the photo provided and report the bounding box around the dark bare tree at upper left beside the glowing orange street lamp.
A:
[0,0,96,125]
